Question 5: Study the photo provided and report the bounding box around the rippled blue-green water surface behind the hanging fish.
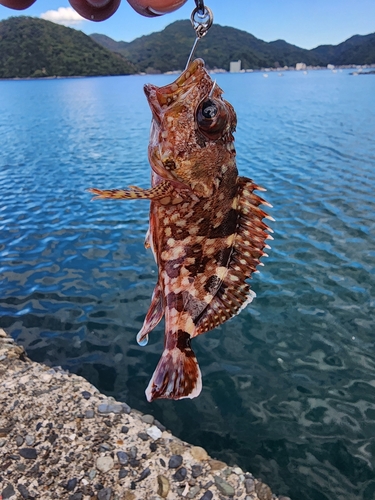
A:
[0,70,375,500]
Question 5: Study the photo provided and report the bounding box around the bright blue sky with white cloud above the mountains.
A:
[0,0,375,49]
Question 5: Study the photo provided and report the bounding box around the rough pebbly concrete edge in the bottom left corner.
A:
[0,329,290,500]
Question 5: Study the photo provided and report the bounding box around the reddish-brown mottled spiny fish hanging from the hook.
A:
[90,59,274,402]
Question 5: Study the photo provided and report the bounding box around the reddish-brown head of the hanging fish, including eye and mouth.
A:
[144,59,237,197]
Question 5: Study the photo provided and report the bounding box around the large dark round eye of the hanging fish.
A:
[196,98,228,140]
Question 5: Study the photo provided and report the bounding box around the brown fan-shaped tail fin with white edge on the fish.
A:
[146,347,202,402]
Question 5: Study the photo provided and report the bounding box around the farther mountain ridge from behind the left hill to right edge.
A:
[91,20,375,72]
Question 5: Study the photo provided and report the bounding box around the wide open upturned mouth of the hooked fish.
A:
[144,59,207,112]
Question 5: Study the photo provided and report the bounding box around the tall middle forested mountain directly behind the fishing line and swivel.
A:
[91,21,320,72]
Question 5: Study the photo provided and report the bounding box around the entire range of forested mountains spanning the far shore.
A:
[0,16,375,78]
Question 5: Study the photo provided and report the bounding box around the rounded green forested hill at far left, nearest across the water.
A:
[0,17,136,78]
